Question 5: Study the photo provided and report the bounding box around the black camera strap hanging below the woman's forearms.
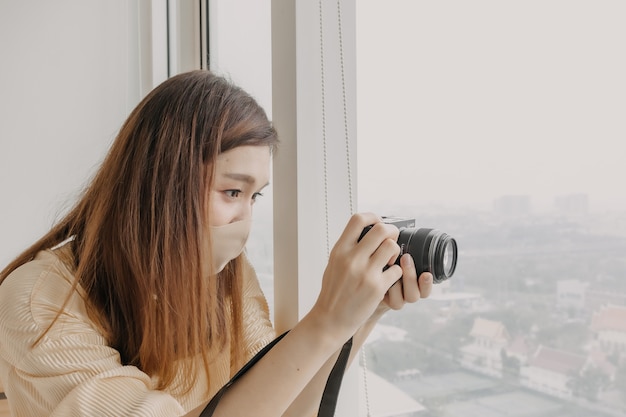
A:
[200,331,352,417]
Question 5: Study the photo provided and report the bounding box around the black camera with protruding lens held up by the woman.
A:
[359,217,458,284]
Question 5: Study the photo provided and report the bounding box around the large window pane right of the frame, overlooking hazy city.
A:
[357,0,626,417]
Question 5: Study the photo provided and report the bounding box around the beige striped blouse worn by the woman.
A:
[0,247,275,417]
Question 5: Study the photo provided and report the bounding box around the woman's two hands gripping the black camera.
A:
[311,213,416,340]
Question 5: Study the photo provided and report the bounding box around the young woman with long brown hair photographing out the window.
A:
[0,71,432,417]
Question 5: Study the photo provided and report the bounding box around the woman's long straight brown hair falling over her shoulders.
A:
[0,70,278,391]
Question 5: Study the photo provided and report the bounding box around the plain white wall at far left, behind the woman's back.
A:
[0,0,139,265]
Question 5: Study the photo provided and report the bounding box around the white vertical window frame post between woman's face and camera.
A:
[272,0,358,416]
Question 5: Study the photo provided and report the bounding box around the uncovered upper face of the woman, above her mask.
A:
[209,145,271,226]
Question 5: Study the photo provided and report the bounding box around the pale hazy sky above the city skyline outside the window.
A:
[357,0,626,210]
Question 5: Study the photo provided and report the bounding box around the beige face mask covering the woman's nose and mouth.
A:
[210,220,251,275]
